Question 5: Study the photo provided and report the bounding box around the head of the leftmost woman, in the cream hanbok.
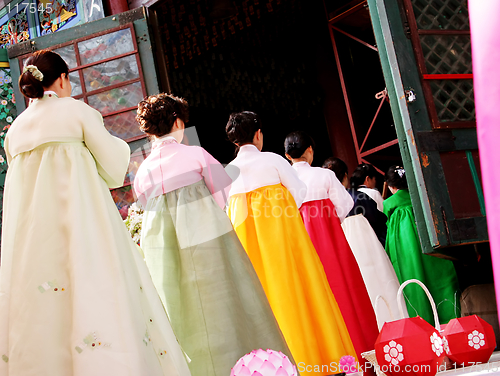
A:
[19,50,71,99]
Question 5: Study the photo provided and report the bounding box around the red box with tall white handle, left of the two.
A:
[375,279,445,376]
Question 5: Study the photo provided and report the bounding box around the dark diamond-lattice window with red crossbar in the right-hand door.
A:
[404,0,475,128]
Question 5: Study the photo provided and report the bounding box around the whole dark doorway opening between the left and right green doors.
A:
[154,0,400,178]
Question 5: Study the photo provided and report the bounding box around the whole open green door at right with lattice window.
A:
[368,0,488,256]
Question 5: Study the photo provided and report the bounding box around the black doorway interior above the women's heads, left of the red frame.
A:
[156,0,344,165]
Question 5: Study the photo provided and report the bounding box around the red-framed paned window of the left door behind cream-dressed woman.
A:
[14,15,154,209]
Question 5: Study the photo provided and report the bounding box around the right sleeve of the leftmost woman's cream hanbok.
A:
[81,104,130,188]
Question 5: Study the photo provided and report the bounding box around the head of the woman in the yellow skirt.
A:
[226,111,264,150]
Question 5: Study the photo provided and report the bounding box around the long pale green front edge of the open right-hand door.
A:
[368,0,438,253]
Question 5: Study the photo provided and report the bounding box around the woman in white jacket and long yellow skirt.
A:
[226,111,356,376]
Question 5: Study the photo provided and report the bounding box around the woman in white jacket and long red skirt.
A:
[285,131,378,368]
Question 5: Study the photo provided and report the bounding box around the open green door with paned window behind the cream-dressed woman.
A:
[8,8,159,211]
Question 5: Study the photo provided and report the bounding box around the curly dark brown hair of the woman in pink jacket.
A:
[135,93,189,137]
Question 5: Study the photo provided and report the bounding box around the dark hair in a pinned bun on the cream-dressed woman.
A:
[19,50,69,98]
